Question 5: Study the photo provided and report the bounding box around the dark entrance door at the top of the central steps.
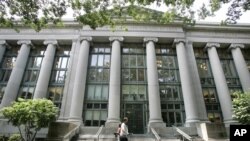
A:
[123,103,145,134]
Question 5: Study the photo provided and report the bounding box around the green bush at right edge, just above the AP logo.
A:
[233,92,250,125]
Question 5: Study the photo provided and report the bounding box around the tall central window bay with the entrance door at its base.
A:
[121,43,148,134]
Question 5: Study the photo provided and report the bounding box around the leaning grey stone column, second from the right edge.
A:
[206,43,234,126]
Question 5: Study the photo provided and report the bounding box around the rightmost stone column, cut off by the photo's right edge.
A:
[229,44,250,92]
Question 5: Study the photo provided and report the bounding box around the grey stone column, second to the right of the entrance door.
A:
[174,39,200,126]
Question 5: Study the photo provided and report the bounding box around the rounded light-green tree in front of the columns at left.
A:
[1,98,58,141]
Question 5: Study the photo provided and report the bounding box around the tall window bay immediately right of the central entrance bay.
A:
[156,44,185,126]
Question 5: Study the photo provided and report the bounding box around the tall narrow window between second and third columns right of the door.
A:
[194,48,222,122]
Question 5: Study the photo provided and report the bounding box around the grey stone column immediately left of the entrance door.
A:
[106,37,123,127]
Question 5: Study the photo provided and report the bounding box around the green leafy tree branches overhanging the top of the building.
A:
[0,0,250,31]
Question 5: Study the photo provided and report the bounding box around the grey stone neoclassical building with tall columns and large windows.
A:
[0,22,250,140]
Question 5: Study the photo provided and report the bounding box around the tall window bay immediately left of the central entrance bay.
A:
[83,44,111,126]
